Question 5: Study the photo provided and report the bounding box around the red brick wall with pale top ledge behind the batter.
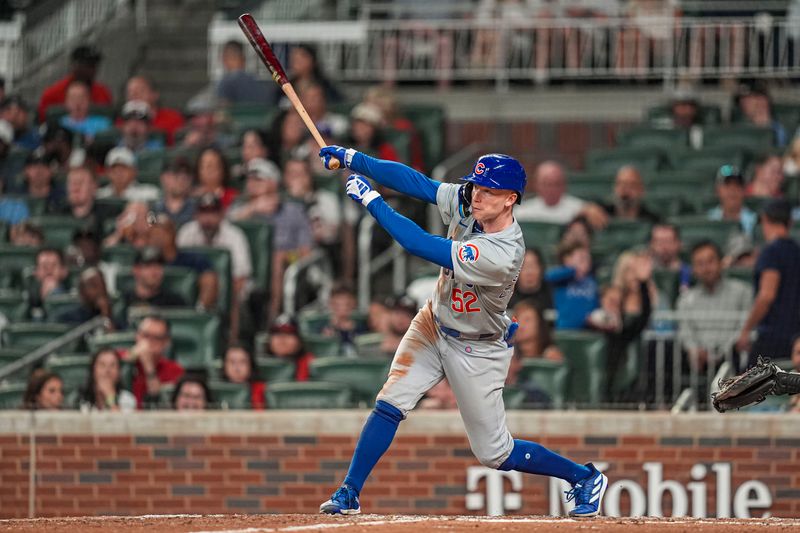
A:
[0,411,800,518]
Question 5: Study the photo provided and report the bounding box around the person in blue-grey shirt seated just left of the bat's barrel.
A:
[217,41,278,105]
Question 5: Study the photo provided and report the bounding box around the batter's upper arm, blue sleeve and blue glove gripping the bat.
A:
[319,145,441,204]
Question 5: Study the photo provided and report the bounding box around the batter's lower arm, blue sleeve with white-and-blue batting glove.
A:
[345,174,453,270]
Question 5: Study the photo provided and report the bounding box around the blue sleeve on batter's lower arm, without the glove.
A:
[366,196,453,270]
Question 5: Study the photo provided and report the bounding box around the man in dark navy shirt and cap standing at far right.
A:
[736,200,800,367]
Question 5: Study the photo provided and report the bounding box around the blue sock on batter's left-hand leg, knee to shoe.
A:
[344,400,403,494]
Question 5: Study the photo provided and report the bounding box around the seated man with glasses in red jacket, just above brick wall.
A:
[122,315,184,409]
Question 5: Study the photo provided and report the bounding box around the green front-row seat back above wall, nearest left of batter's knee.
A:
[266,381,353,409]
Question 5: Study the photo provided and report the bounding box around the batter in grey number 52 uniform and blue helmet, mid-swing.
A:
[320,146,608,517]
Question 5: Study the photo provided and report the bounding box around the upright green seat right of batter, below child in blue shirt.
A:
[554,330,606,408]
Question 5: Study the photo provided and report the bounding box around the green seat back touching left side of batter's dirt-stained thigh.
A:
[311,357,391,406]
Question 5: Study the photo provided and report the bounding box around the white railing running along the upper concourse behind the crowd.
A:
[209,15,800,88]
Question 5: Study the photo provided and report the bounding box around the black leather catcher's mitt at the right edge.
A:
[711,356,780,413]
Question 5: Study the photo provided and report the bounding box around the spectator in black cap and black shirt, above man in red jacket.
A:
[120,246,189,323]
